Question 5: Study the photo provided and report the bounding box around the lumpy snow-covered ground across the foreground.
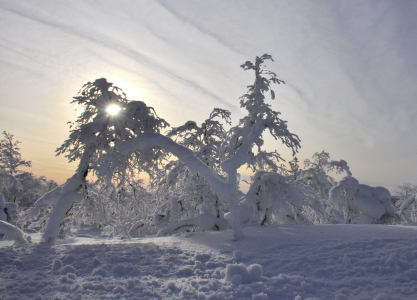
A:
[0,225,417,300]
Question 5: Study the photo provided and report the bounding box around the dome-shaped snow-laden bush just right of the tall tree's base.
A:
[241,171,327,225]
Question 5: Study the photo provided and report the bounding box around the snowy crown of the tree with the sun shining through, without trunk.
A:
[56,78,169,184]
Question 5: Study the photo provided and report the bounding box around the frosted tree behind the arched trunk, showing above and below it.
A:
[145,108,231,231]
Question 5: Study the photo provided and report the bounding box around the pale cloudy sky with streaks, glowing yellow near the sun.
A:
[0,0,417,191]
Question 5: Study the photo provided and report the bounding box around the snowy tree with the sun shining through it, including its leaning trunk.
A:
[32,78,168,243]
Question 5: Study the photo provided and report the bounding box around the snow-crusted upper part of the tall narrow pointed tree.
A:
[222,54,301,172]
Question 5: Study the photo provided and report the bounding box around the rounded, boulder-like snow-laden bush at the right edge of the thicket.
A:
[328,177,398,224]
